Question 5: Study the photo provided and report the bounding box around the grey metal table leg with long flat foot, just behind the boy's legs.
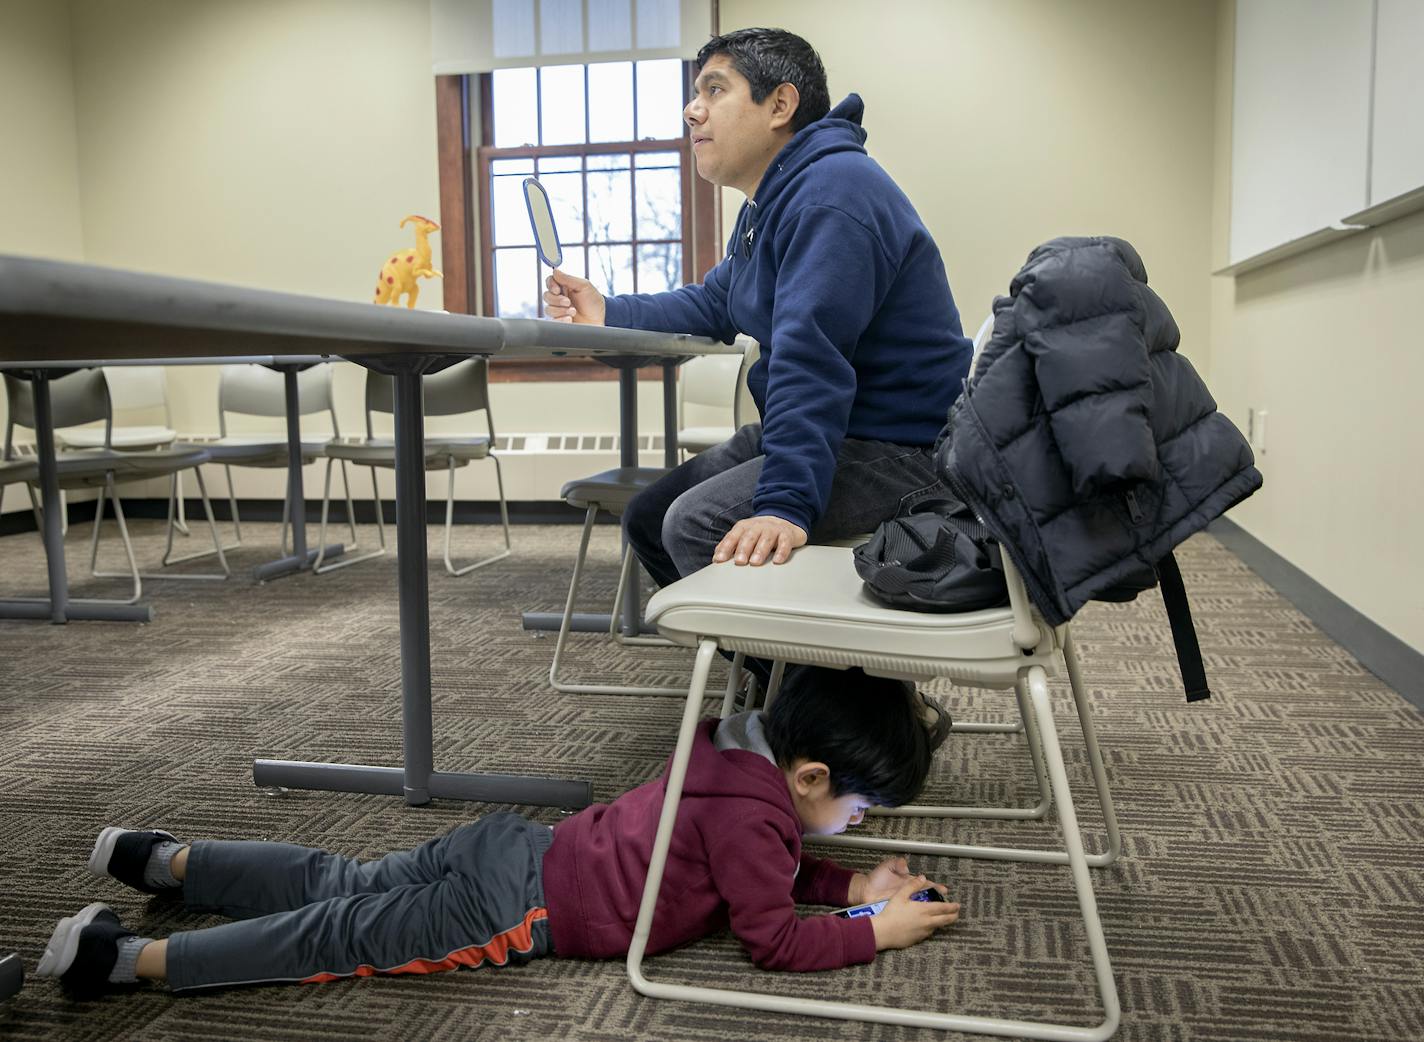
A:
[252,360,592,807]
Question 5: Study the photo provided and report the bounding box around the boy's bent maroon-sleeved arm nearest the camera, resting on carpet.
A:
[708,821,876,971]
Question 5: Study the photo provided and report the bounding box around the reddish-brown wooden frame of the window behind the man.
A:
[436,61,721,383]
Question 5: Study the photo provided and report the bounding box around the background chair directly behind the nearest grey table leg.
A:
[312,359,511,575]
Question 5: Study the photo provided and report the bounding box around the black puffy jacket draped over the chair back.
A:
[938,236,1262,625]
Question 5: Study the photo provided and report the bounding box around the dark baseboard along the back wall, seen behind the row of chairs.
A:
[0,497,606,535]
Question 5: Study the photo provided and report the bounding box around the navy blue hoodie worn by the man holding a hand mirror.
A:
[604,94,971,532]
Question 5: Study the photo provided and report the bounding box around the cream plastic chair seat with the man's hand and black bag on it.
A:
[646,547,1058,688]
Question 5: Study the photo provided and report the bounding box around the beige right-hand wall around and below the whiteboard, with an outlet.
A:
[1210,3,1424,651]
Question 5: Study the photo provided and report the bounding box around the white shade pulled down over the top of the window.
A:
[430,0,712,75]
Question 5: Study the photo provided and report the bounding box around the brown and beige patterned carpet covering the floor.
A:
[0,522,1424,1042]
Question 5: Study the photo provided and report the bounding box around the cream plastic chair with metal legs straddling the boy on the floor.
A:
[628,547,1122,1042]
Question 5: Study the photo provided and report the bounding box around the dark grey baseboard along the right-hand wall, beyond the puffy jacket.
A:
[1206,518,1424,709]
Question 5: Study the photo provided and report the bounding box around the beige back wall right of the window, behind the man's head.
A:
[721,0,1215,370]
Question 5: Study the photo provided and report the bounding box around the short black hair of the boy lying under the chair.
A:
[763,666,950,807]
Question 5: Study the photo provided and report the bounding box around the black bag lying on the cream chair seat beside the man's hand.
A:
[853,490,1008,612]
